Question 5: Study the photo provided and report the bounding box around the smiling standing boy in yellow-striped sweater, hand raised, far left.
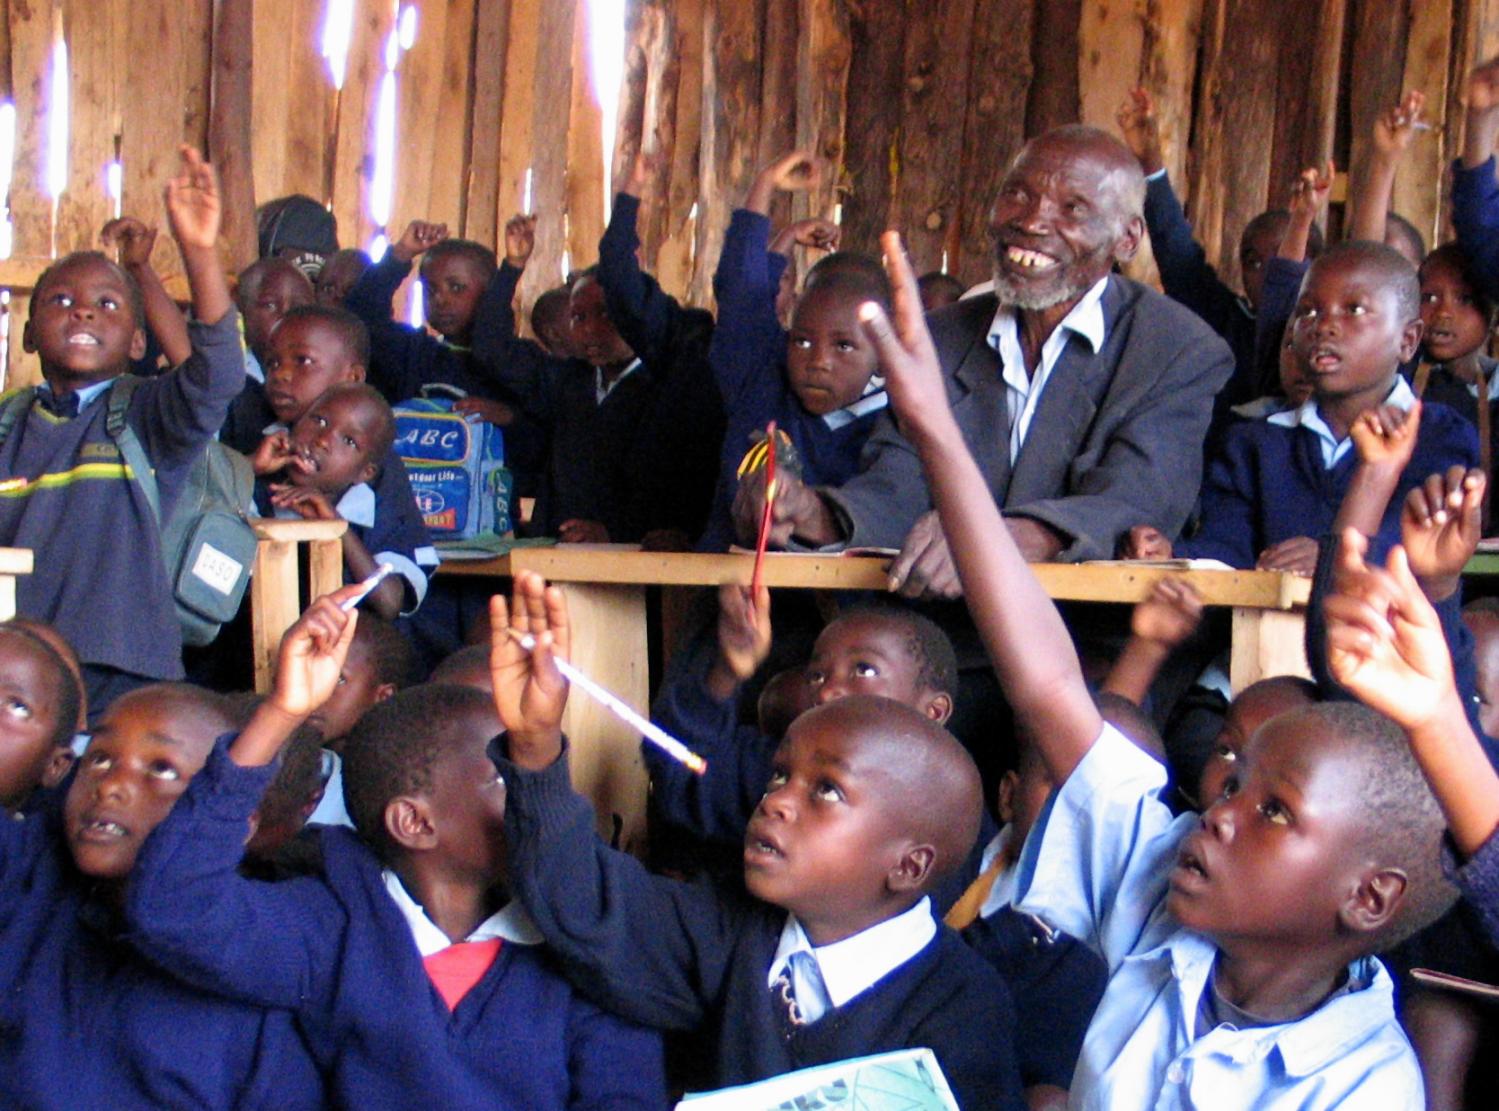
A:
[0,148,244,714]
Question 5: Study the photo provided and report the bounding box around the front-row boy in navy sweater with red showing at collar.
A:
[119,588,664,1111]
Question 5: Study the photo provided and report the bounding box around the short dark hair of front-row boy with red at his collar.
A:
[343,684,495,861]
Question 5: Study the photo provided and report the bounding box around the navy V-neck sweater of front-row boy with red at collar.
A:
[126,738,666,1111]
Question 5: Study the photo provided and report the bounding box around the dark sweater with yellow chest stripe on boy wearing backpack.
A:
[0,309,244,679]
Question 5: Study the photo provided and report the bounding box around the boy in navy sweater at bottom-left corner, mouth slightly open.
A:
[0,684,324,1111]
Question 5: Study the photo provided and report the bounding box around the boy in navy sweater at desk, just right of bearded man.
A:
[1127,243,1478,574]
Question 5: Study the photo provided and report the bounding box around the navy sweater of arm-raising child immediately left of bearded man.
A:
[699,208,886,552]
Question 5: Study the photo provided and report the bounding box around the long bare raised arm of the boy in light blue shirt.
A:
[860,232,1103,783]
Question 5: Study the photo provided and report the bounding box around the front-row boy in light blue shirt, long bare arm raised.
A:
[869,232,1451,1108]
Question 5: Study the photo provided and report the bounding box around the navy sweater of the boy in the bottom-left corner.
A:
[0,796,324,1111]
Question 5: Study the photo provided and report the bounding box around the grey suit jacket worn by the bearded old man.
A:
[821,274,1234,561]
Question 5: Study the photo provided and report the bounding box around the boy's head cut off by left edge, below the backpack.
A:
[0,622,82,822]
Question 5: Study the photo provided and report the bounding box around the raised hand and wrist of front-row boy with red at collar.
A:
[229,585,360,768]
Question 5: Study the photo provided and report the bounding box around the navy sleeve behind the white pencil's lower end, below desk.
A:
[640,654,776,841]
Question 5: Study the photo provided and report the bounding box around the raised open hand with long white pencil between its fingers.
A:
[489,571,571,768]
